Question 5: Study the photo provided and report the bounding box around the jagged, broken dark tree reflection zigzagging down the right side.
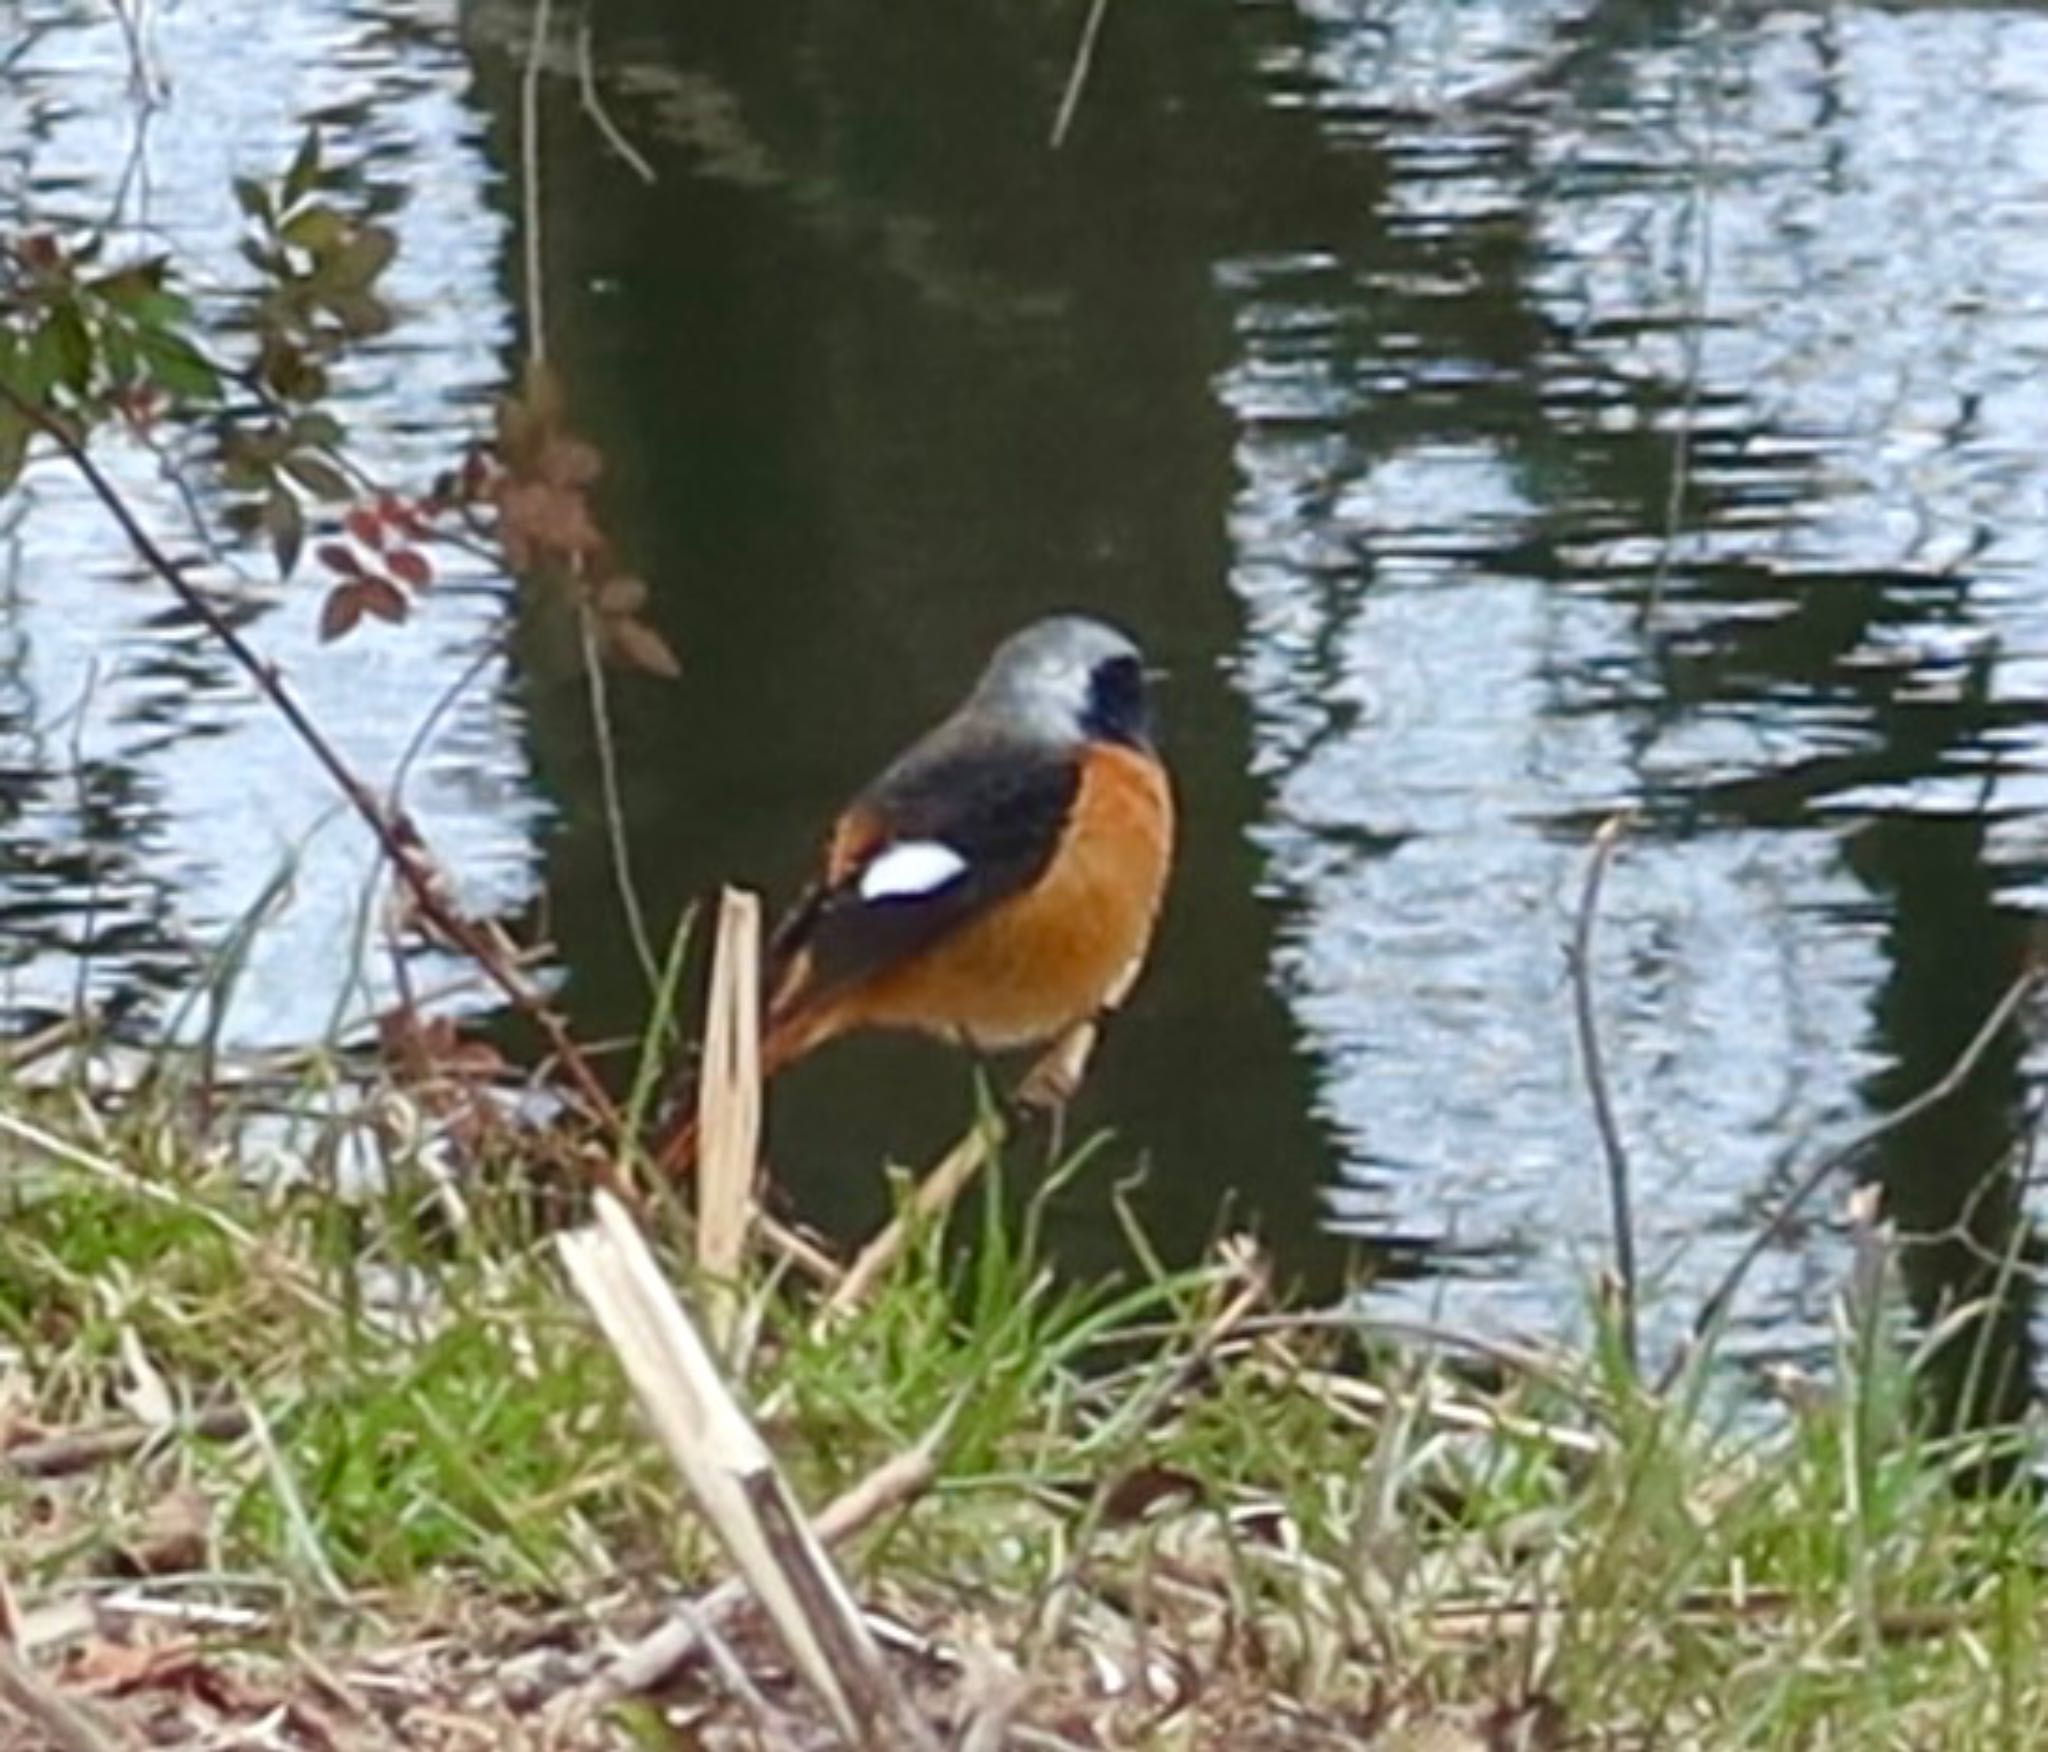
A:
[1228,4,2032,1422]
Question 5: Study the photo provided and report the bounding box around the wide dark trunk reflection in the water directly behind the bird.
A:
[479,0,1372,1289]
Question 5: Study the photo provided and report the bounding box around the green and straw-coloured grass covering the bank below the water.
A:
[0,1049,2048,1748]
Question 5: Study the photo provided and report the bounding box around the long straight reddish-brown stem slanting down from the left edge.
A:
[0,381,625,1172]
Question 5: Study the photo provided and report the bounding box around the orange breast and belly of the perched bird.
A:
[829,744,1174,1051]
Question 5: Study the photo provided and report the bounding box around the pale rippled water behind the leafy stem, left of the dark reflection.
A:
[0,0,545,1043]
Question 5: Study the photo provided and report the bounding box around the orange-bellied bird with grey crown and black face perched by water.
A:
[655,615,1176,1174]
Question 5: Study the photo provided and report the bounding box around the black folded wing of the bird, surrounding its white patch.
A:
[774,742,1081,998]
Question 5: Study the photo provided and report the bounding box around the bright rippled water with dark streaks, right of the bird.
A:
[1223,8,2048,1368]
